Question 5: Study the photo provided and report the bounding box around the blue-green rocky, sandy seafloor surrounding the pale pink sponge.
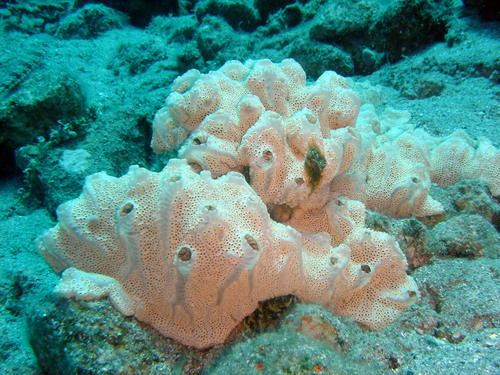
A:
[0,0,500,375]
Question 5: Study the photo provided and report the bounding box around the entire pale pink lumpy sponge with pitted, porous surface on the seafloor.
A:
[37,60,500,348]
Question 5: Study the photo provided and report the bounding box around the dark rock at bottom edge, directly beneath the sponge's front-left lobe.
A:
[28,300,218,375]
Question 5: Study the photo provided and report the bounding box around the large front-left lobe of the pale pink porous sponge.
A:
[37,159,301,348]
